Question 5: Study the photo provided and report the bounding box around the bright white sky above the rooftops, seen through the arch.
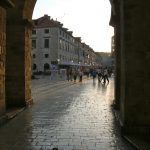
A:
[33,0,114,52]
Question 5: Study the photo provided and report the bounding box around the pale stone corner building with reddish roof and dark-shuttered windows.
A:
[32,15,84,72]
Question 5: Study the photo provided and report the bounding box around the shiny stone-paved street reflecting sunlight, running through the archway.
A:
[0,79,134,150]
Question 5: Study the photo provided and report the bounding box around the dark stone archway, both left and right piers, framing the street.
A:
[0,0,150,136]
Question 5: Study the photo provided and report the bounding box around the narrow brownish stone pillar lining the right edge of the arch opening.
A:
[110,0,121,110]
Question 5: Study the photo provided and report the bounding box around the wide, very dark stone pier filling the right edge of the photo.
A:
[121,0,150,134]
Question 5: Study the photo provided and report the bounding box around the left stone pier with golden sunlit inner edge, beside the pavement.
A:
[6,13,33,108]
